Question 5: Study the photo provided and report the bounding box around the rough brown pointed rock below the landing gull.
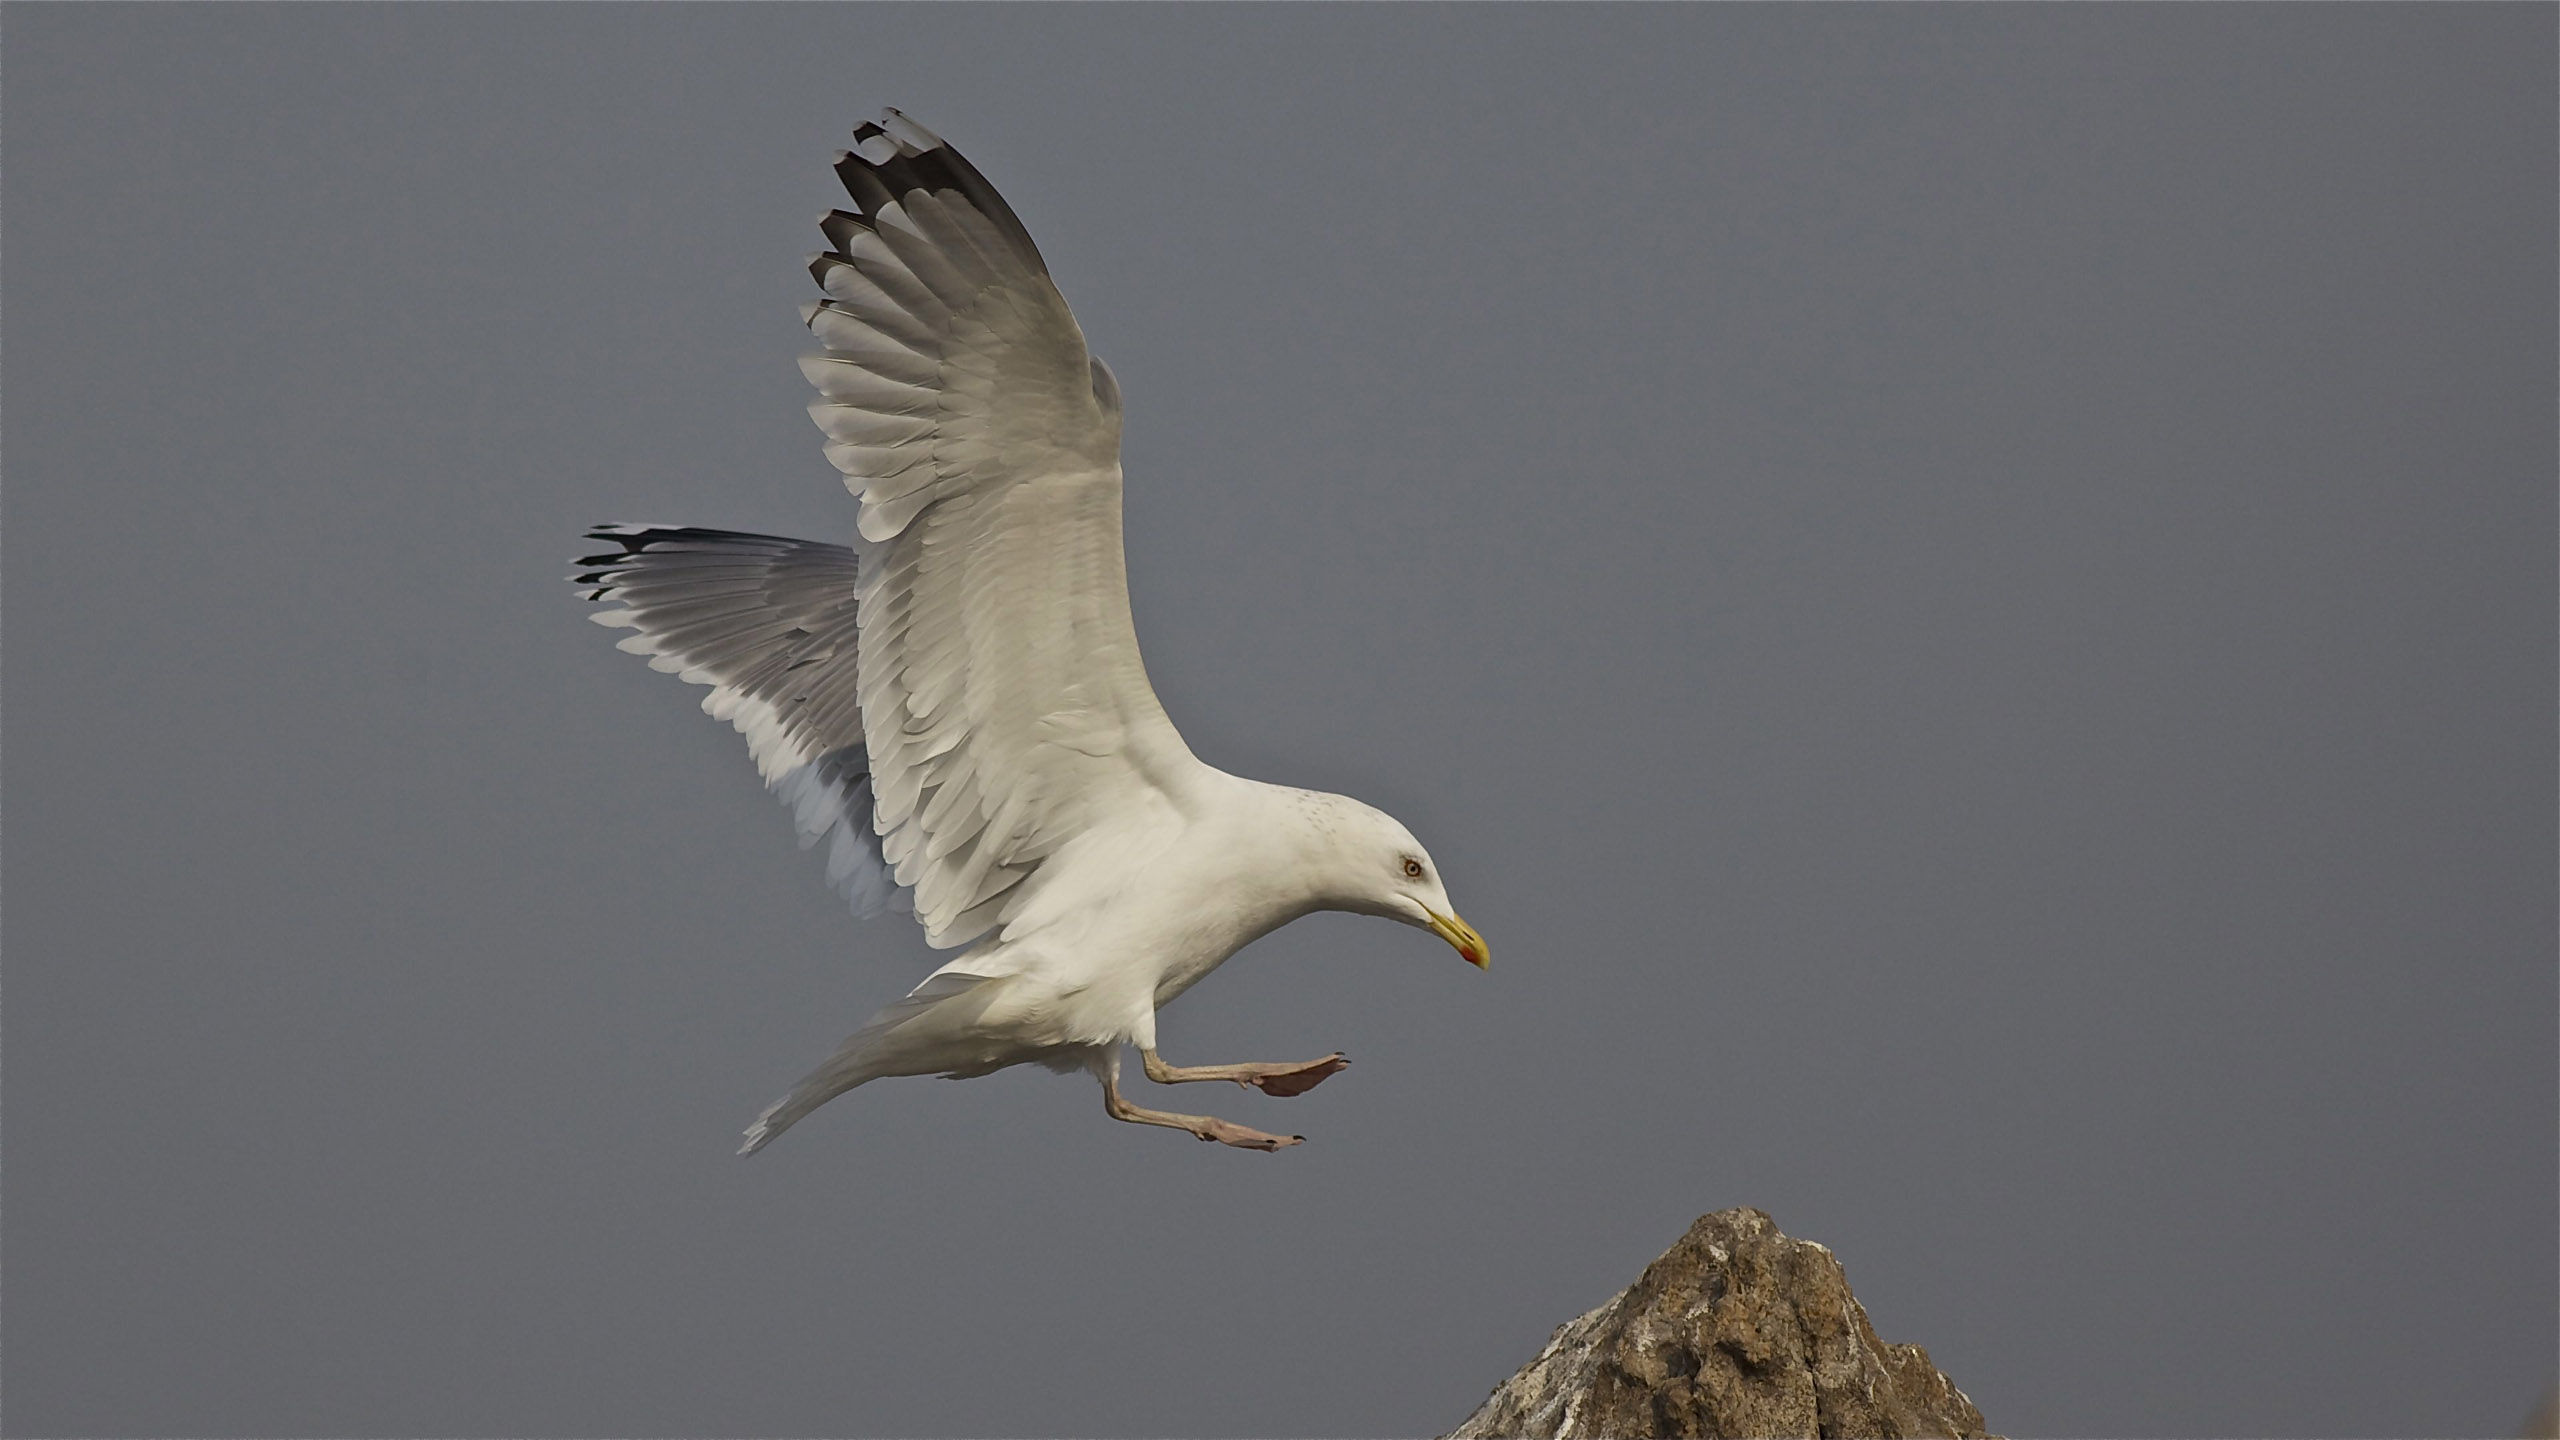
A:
[1446,1209,1987,1440]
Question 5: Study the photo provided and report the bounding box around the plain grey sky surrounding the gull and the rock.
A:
[5,5,2560,1435]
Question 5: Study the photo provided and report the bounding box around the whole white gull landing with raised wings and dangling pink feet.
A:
[571,110,1485,1156]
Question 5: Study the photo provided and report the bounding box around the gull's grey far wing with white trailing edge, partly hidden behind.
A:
[571,525,906,915]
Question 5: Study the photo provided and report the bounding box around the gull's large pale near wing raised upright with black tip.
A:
[801,110,1198,948]
